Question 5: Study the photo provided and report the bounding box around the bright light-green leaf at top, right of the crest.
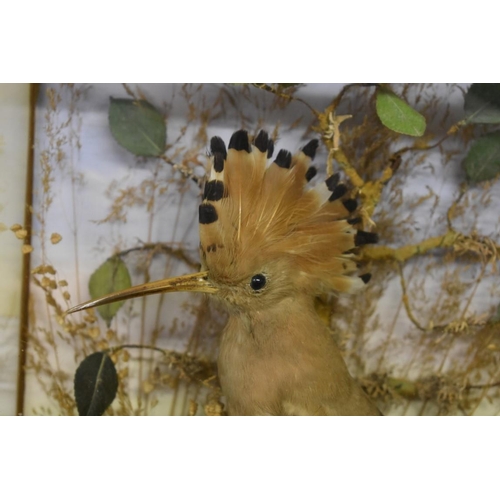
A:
[376,88,425,137]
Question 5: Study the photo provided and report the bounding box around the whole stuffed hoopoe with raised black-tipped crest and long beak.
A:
[68,130,380,415]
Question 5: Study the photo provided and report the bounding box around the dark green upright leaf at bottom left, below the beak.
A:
[74,351,118,416]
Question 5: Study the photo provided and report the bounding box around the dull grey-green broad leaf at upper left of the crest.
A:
[109,98,167,156]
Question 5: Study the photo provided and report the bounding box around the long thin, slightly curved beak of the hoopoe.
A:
[65,271,218,314]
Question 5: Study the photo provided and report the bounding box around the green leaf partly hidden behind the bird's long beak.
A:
[89,257,132,326]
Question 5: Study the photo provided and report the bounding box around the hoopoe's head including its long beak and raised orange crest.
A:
[68,130,376,313]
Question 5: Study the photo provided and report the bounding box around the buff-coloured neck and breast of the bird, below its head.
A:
[218,306,379,415]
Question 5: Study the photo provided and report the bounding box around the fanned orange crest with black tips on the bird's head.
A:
[199,130,377,292]
